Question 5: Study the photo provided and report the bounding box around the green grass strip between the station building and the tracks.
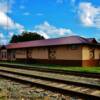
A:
[0,62,100,73]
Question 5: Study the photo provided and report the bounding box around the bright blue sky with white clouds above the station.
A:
[0,0,100,44]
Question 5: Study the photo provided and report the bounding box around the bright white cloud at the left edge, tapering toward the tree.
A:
[0,0,24,30]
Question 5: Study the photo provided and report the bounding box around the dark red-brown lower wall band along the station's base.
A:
[8,59,100,67]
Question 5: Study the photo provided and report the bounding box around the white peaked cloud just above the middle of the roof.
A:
[34,21,74,38]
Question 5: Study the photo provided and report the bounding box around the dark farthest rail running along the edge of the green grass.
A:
[0,63,100,78]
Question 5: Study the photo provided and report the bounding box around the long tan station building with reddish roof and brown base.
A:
[0,36,100,67]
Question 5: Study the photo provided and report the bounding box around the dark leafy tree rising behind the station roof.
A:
[10,31,45,43]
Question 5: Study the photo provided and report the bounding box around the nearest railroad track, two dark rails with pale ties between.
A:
[0,67,100,100]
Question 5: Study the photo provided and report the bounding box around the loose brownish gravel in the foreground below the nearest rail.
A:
[0,77,83,100]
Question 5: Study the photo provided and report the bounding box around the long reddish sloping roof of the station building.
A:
[6,36,97,49]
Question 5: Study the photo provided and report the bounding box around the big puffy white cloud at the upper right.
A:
[78,2,100,28]
